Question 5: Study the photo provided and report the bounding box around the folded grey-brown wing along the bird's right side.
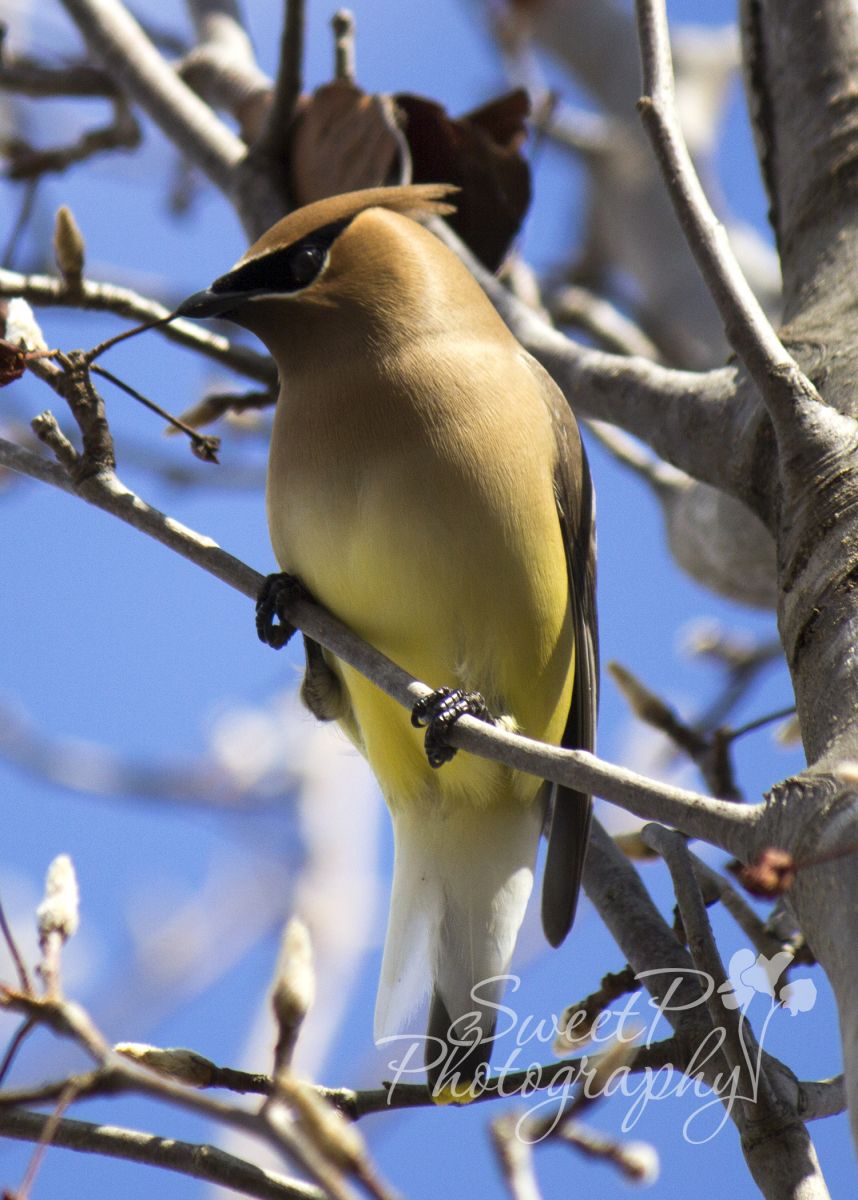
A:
[523,360,599,946]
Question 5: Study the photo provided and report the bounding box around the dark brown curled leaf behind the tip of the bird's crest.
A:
[394,89,530,270]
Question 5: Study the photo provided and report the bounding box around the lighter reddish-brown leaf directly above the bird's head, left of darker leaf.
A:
[289,79,405,205]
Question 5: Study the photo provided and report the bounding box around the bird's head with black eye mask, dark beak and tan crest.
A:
[175,184,457,356]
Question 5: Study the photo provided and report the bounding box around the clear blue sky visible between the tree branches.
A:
[0,0,853,1200]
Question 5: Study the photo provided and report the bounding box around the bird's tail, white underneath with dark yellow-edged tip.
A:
[376,800,542,1099]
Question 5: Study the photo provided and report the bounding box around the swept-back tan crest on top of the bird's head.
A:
[241,184,460,263]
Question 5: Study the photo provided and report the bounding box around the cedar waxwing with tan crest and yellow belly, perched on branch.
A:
[178,185,598,1099]
